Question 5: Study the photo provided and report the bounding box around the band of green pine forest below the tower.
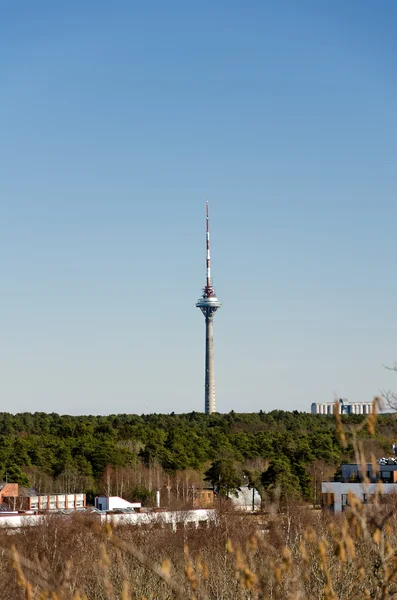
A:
[0,411,397,502]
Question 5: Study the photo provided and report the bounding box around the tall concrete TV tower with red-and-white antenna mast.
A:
[196,201,222,414]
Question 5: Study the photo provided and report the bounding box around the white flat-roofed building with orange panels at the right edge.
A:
[321,458,397,512]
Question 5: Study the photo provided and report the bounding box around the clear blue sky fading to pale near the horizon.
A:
[0,0,397,414]
